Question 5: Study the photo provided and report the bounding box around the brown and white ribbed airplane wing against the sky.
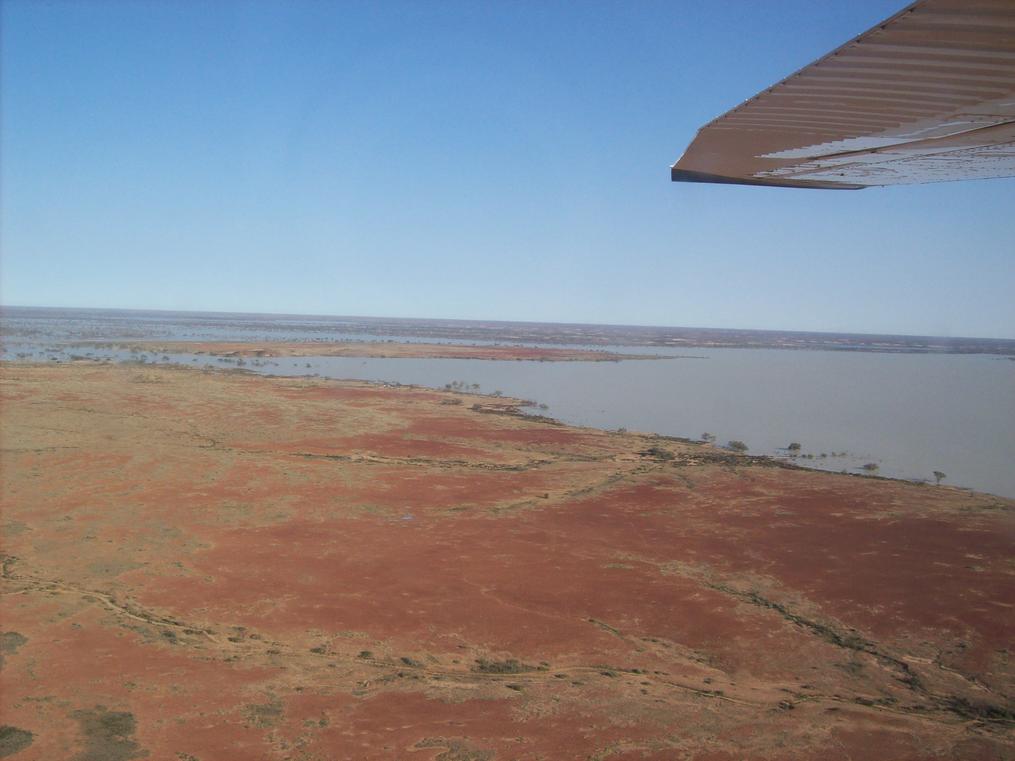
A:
[670,0,1015,189]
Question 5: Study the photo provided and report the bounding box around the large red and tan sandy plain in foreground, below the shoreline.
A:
[0,363,1015,761]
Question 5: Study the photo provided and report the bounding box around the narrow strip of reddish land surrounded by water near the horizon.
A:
[93,341,662,362]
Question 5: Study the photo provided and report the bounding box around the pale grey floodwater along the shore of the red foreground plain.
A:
[3,310,1015,497]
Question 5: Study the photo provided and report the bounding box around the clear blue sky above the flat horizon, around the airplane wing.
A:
[0,0,1015,338]
